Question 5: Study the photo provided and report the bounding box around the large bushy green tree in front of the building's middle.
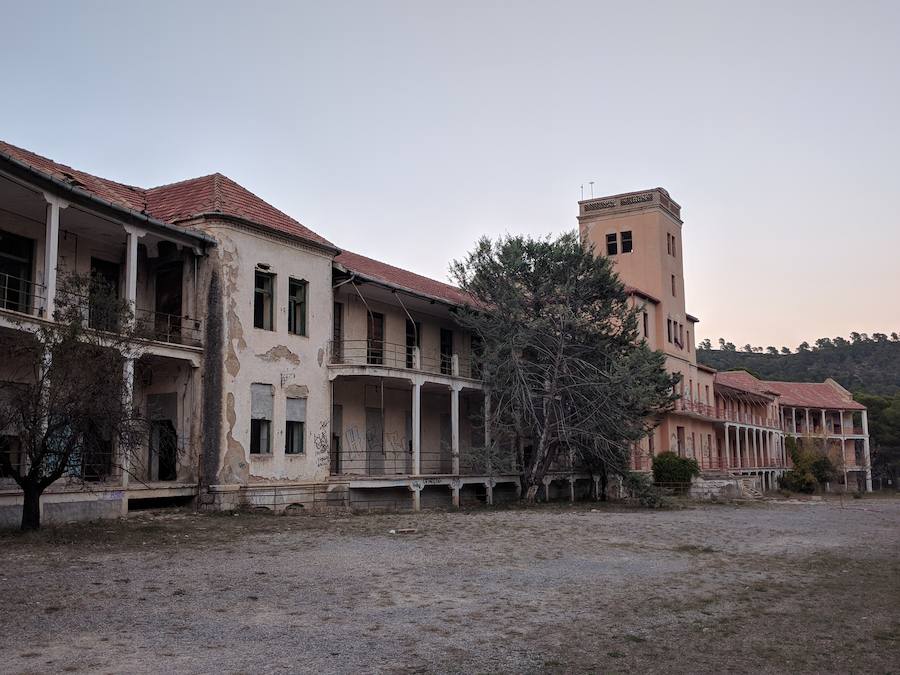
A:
[452,232,678,501]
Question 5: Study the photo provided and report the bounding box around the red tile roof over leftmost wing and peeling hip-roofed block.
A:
[0,141,337,250]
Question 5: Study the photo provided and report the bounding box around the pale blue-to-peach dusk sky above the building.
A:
[0,0,900,347]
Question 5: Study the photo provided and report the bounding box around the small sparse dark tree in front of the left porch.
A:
[0,275,146,530]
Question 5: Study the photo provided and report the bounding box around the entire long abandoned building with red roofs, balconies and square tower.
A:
[0,142,871,525]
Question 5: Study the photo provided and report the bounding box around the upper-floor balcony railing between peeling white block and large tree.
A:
[328,340,482,377]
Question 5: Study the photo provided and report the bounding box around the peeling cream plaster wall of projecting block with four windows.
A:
[193,220,332,485]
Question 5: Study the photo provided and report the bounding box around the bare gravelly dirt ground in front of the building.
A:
[0,498,900,673]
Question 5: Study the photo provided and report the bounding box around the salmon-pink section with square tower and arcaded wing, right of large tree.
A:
[578,188,872,491]
